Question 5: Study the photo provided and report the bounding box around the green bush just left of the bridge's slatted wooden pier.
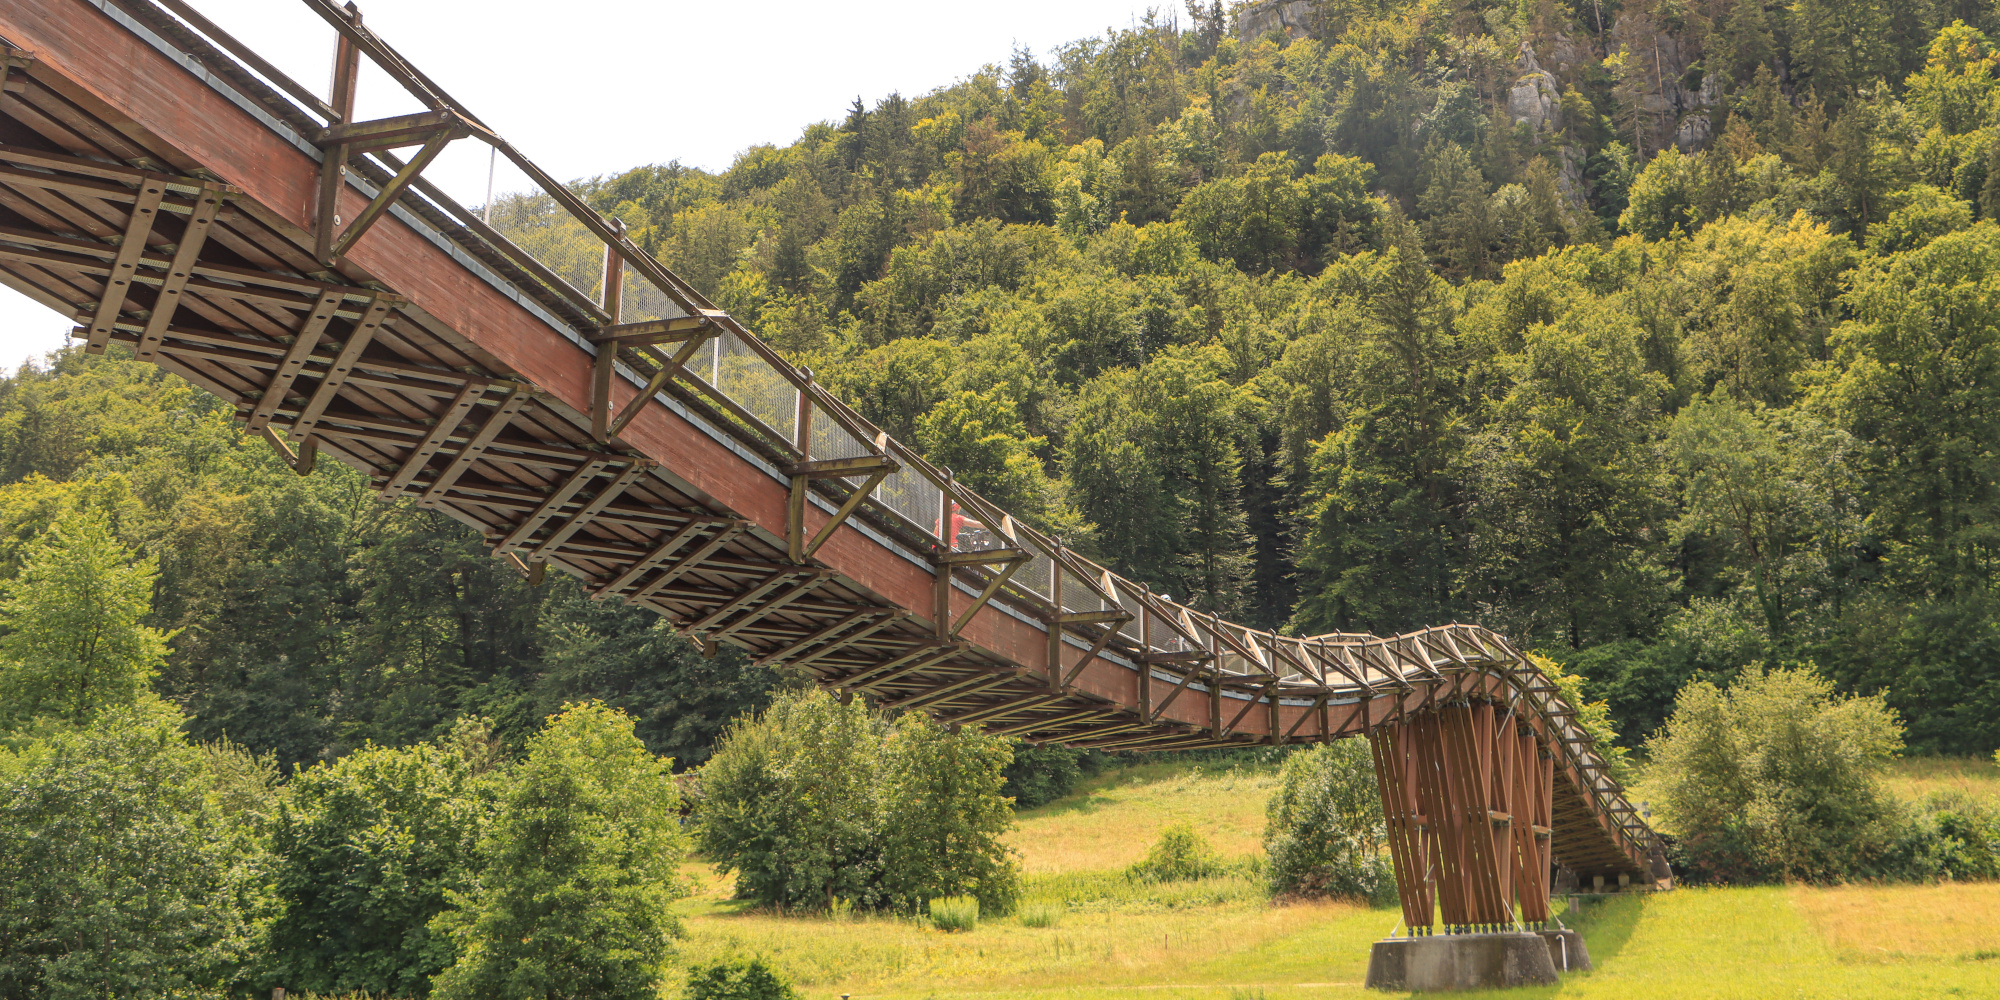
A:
[1264,740,1396,902]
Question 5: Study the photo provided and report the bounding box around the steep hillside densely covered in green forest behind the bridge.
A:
[11,0,2000,762]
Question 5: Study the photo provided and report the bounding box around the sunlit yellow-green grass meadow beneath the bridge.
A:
[682,760,2000,1000]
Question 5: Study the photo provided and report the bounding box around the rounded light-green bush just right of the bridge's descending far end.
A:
[1646,666,1902,882]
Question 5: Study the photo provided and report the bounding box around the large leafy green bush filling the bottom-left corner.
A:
[0,702,260,998]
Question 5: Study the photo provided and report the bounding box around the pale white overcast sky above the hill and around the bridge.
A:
[0,0,1176,368]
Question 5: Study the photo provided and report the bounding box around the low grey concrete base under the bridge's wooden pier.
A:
[1368,930,1590,992]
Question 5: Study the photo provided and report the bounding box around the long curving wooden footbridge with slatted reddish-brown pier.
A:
[0,0,1662,932]
